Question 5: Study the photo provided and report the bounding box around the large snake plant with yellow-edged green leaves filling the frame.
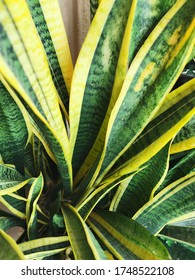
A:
[0,0,195,260]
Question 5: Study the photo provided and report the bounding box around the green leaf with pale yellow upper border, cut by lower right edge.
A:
[133,172,195,234]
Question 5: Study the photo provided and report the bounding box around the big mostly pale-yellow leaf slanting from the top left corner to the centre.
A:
[0,0,72,193]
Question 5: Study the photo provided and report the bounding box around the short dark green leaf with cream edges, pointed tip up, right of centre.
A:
[111,143,170,217]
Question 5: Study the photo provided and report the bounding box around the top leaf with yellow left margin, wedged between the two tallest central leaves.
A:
[112,0,176,104]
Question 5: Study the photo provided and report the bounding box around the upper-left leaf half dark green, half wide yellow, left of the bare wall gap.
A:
[27,0,73,116]
